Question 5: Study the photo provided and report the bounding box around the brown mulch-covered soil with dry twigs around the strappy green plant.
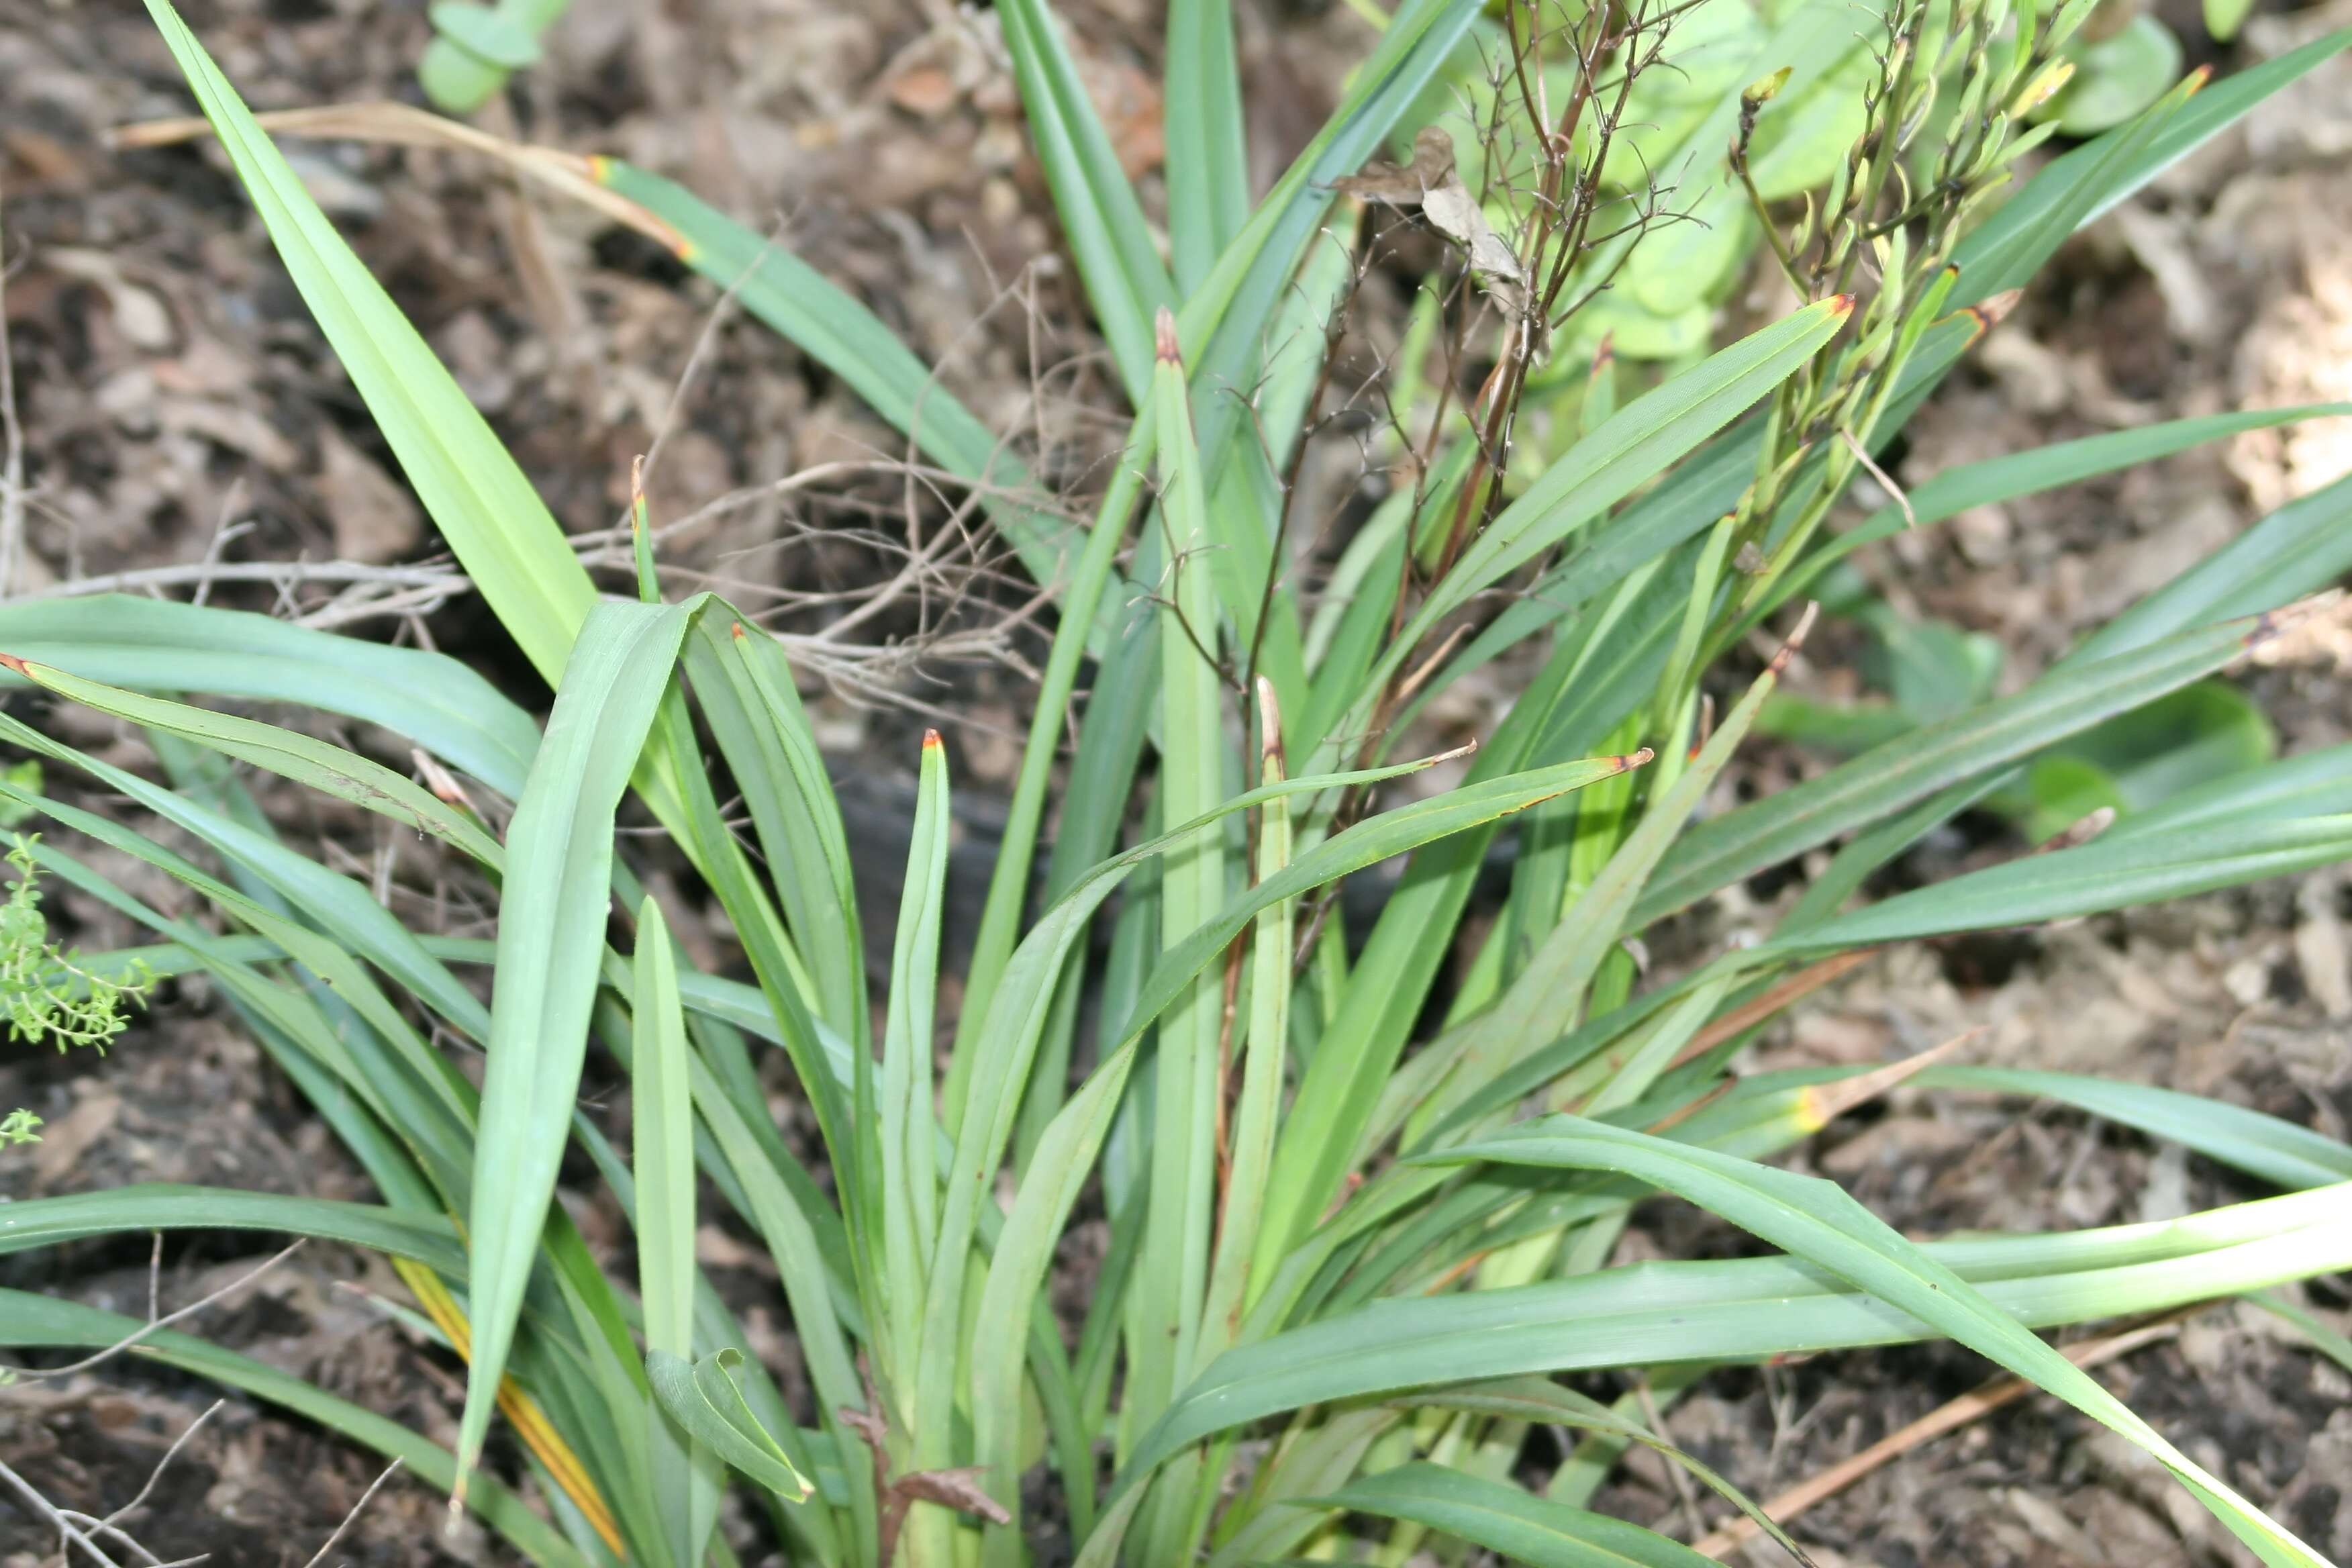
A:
[0,0,2352,1568]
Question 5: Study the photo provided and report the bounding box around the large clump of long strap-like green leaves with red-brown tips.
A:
[0,0,2352,1568]
